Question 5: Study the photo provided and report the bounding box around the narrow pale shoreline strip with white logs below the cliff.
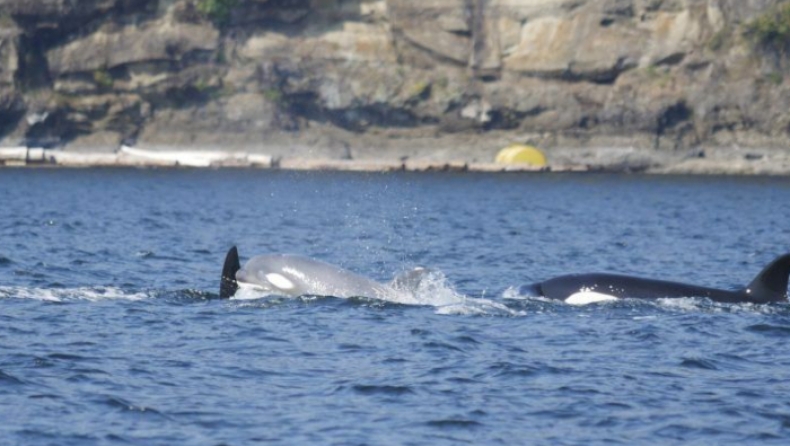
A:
[0,141,790,176]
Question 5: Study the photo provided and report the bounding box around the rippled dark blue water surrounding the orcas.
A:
[0,170,790,445]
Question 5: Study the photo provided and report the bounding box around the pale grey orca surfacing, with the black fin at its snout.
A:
[219,246,414,303]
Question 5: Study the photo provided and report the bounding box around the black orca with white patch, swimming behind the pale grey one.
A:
[522,254,790,305]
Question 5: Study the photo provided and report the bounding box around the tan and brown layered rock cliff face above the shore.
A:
[0,0,790,158]
